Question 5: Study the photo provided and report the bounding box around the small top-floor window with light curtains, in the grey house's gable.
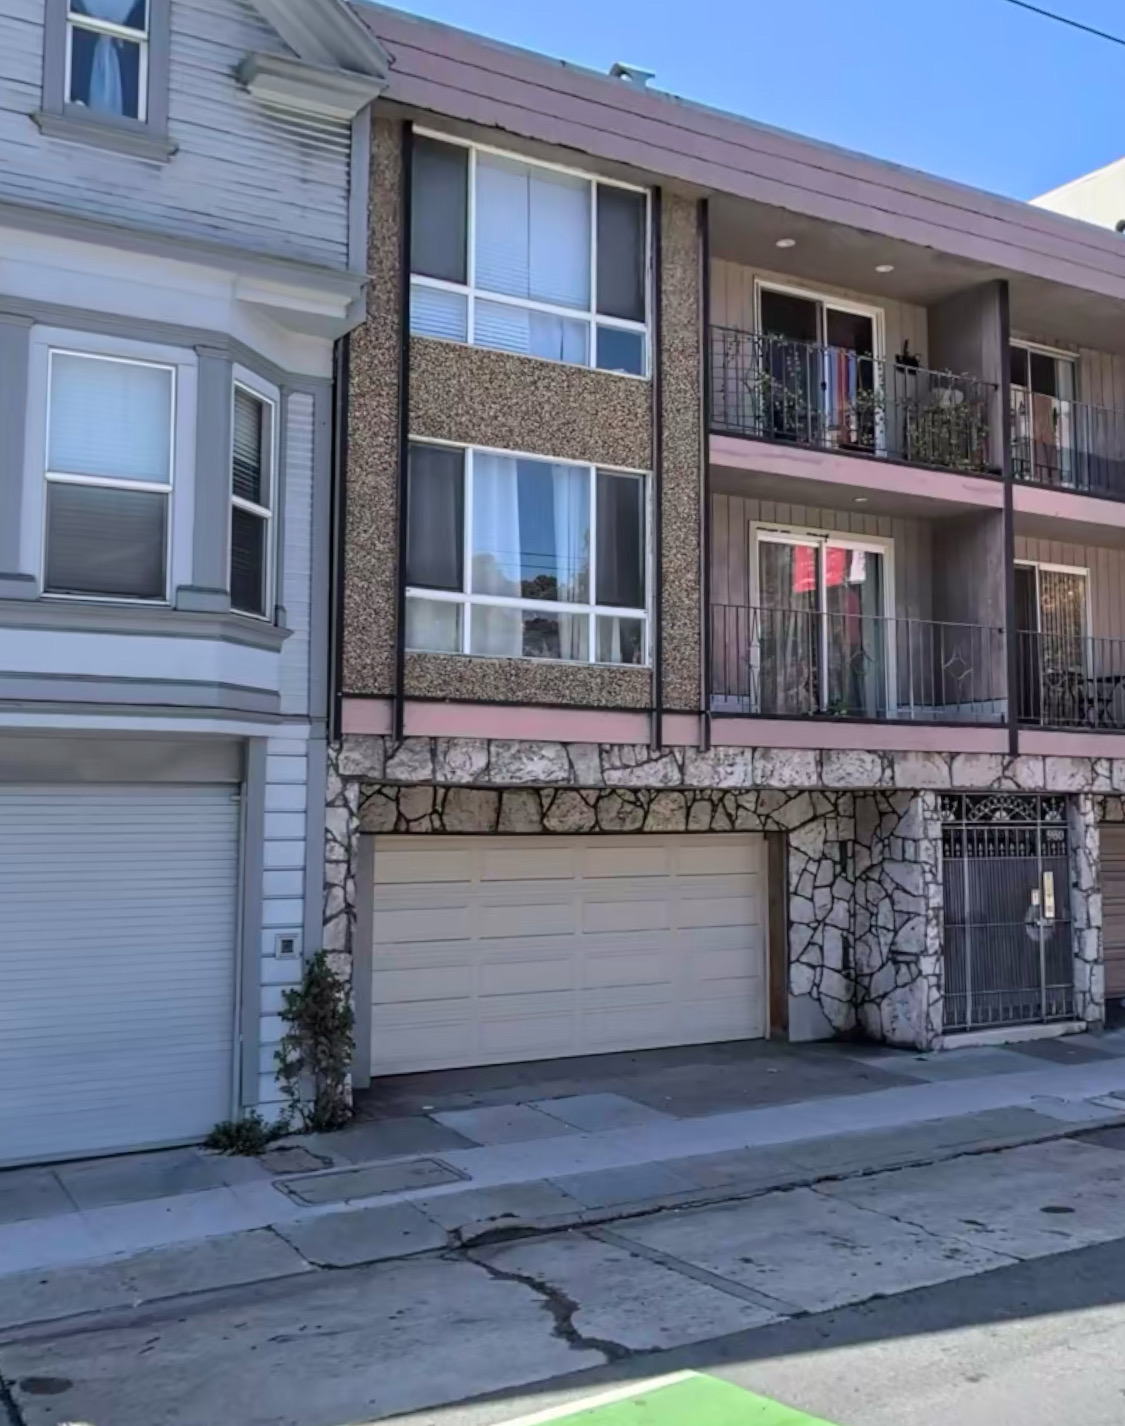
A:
[63,0,150,124]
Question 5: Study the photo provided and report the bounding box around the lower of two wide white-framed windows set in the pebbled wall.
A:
[406,441,650,665]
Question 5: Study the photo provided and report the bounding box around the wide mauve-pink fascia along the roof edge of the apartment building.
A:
[356,6,1125,298]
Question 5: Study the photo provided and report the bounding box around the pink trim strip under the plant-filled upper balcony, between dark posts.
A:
[710,436,1004,511]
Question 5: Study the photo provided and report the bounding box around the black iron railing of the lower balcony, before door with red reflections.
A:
[710,603,1008,724]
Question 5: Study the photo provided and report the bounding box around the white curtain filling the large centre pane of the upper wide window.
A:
[475,154,590,308]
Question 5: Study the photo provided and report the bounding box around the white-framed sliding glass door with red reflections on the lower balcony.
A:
[751,530,891,717]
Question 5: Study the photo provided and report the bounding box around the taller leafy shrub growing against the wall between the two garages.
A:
[275,951,355,1134]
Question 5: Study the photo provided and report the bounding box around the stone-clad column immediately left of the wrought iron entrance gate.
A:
[853,791,944,1050]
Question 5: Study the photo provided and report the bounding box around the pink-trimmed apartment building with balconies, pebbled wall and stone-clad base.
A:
[324,6,1125,1084]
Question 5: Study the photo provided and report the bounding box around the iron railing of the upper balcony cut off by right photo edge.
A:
[1011,386,1125,499]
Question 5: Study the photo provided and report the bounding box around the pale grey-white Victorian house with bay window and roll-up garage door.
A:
[0,0,385,1164]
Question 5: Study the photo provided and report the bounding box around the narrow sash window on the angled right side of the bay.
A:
[230,381,277,619]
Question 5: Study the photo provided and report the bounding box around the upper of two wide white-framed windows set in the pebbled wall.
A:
[411,131,652,376]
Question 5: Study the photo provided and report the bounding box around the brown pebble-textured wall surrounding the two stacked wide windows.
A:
[344,120,702,710]
